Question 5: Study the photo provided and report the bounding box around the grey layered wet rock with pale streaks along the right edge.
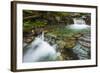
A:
[73,35,91,60]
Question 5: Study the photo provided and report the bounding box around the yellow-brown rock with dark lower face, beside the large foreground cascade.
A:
[57,37,78,60]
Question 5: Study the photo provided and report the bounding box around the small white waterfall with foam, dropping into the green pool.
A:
[66,18,90,29]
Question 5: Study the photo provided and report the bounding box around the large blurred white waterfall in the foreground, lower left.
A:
[23,32,58,62]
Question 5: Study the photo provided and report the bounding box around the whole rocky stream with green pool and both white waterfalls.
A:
[23,19,91,62]
